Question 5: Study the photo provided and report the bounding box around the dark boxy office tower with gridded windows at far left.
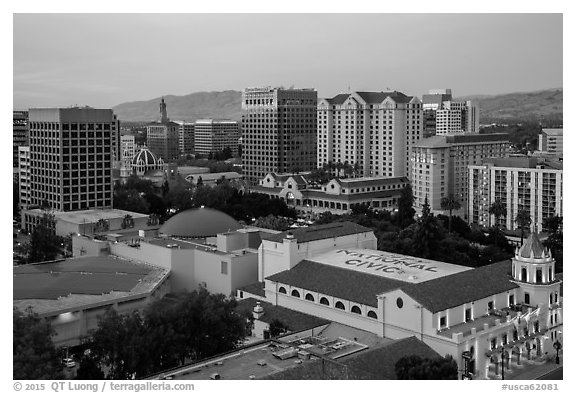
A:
[29,107,119,211]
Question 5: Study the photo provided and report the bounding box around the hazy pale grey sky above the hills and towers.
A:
[13,14,563,109]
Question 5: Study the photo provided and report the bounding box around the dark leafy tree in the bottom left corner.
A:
[12,308,64,379]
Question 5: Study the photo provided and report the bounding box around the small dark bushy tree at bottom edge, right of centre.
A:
[394,355,458,380]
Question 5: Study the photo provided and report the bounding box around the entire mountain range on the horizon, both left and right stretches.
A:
[113,88,563,124]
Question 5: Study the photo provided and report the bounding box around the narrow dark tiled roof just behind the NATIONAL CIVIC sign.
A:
[267,221,372,243]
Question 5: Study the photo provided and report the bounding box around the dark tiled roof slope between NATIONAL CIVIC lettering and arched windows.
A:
[266,260,404,307]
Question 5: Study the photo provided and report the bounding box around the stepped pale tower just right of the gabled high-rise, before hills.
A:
[422,89,480,138]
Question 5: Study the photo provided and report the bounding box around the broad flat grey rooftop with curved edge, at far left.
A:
[13,256,169,315]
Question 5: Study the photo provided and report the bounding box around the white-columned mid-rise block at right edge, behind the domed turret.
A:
[467,157,563,231]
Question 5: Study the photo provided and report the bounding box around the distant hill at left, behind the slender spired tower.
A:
[112,90,242,122]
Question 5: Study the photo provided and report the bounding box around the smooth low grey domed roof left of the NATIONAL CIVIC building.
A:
[160,207,242,237]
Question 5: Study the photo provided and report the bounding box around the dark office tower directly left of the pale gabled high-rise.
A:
[242,87,318,185]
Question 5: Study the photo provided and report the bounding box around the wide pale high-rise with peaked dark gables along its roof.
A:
[318,91,422,177]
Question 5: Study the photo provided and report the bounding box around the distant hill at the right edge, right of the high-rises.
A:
[457,88,563,124]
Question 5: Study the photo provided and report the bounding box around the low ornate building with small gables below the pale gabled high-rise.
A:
[251,173,409,214]
